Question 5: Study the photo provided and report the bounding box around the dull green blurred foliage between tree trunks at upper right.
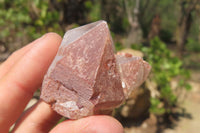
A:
[139,0,178,38]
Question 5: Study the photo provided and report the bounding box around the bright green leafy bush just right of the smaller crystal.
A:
[142,37,191,114]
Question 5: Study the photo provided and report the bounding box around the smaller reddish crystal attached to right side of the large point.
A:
[116,53,151,98]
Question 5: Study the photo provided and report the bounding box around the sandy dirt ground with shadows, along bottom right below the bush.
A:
[124,70,200,133]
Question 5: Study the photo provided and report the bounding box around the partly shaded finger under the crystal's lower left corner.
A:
[12,101,61,133]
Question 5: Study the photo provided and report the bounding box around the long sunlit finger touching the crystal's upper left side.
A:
[0,33,61,131]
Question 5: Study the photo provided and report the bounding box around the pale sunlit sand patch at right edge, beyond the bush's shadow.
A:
[164,71,200,133]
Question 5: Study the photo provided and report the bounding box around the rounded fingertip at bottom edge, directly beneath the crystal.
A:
[50,116,123,133]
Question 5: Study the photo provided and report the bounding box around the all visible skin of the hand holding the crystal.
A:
[0,33,123,133]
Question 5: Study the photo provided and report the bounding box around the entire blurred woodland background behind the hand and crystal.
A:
[0,0,200,133]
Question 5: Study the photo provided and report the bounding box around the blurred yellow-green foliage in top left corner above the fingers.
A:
[0,0,62,51]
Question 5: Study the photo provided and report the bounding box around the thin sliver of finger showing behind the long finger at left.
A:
[0,37,42,79]
